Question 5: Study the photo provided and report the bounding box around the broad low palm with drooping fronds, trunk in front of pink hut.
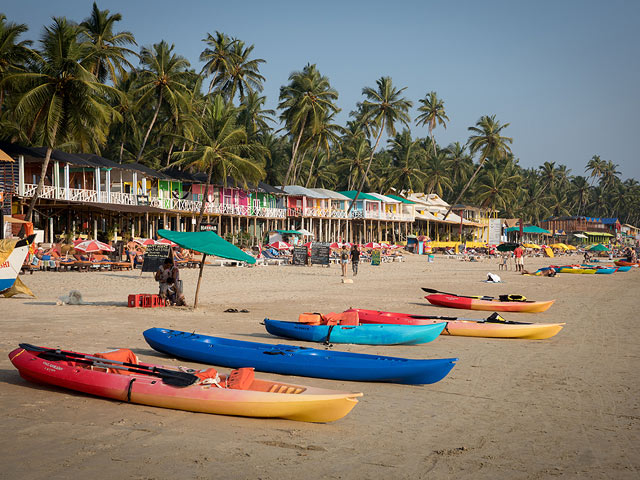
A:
[172,95,265,231]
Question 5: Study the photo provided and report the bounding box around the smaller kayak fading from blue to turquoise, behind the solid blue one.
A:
[264,318,446,345]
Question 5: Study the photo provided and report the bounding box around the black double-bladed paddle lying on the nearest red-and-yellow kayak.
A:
[19,343,200,387]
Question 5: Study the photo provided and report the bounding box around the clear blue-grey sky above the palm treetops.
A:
[5,0,640,180]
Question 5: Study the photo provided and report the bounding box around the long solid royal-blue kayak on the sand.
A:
[143,328,458,385]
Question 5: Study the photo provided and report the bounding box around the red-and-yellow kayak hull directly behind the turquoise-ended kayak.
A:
[348,308,565,340]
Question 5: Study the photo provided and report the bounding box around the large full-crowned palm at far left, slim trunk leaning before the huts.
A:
[8,18,119,221]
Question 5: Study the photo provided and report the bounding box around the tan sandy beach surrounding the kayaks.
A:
[0,255,640,480]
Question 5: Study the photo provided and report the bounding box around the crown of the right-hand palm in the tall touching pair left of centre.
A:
[220,40,265,102]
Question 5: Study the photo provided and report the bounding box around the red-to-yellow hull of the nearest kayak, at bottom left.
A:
[9,348,362,422]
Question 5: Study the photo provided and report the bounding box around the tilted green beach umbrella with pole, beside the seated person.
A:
[158,229,256,308]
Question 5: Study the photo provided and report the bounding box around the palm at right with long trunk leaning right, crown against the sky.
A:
[444,115,513,220]
